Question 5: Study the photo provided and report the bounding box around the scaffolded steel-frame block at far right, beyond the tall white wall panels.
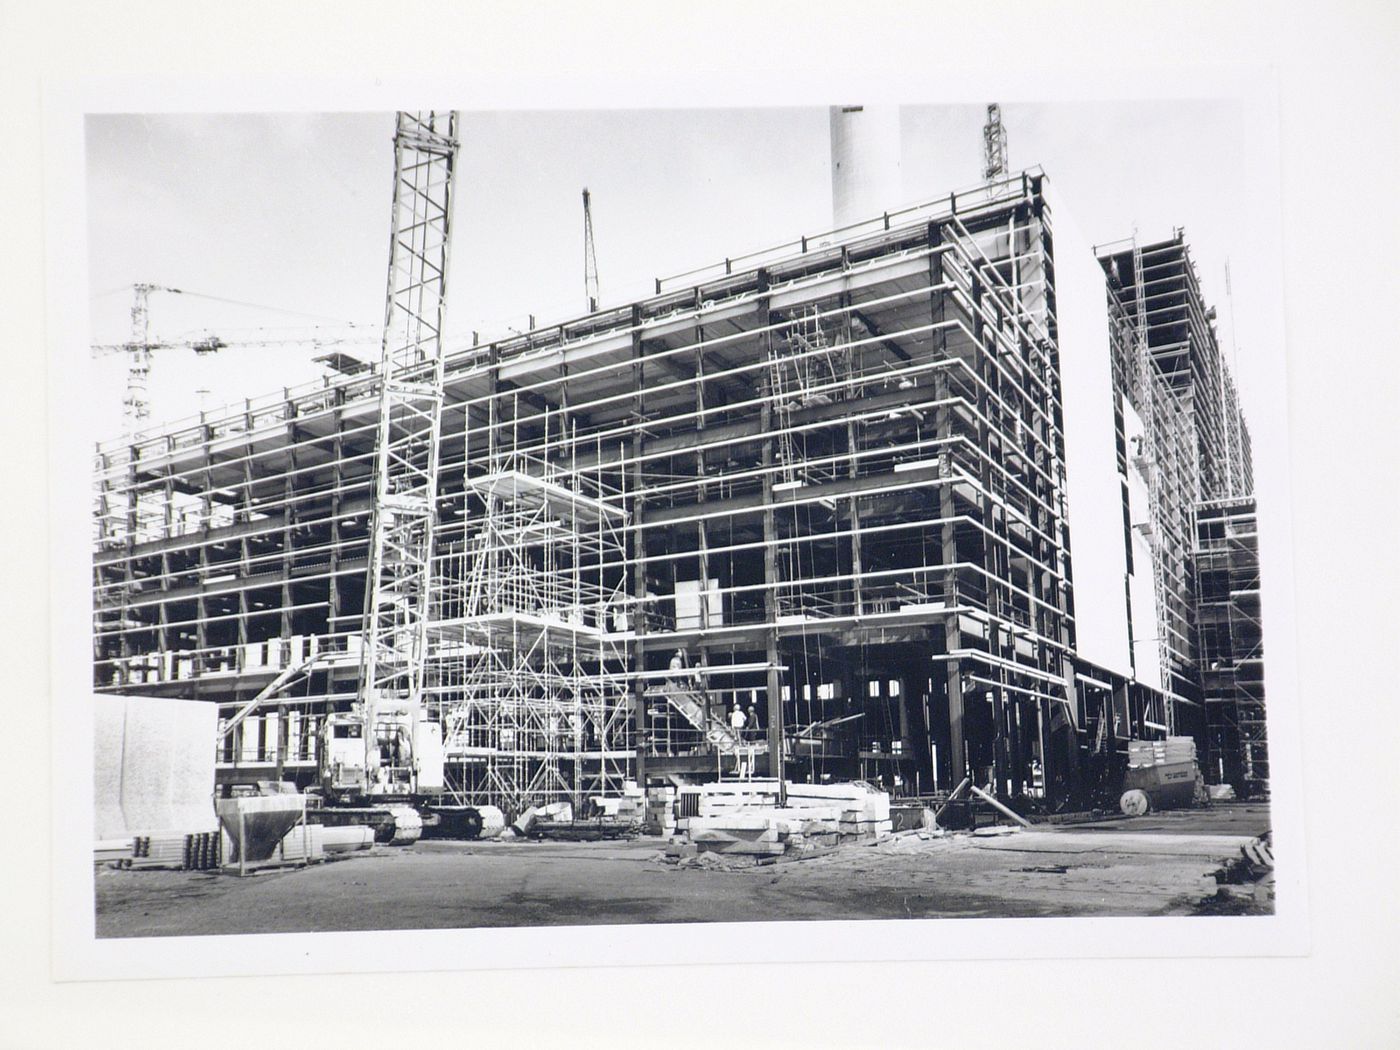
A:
[1099,230,1268,792]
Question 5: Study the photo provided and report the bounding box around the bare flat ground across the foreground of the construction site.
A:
[97,804,1271,937]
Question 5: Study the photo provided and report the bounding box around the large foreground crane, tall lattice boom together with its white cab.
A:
[322,112,458,841]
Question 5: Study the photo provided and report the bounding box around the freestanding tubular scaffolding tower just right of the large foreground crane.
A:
[427,422,631,812]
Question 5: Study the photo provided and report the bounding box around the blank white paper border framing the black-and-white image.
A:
[43,66,1309,980]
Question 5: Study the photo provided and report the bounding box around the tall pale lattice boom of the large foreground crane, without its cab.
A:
[358,112,458,790]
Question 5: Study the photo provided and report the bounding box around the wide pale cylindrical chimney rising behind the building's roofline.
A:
[832,106,904,227]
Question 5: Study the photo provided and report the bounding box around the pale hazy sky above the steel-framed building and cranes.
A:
[87,99,1282,437]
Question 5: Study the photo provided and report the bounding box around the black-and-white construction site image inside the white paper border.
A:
[79,102,1275,937]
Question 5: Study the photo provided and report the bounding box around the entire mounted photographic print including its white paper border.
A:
[0,4,1394,1046]
